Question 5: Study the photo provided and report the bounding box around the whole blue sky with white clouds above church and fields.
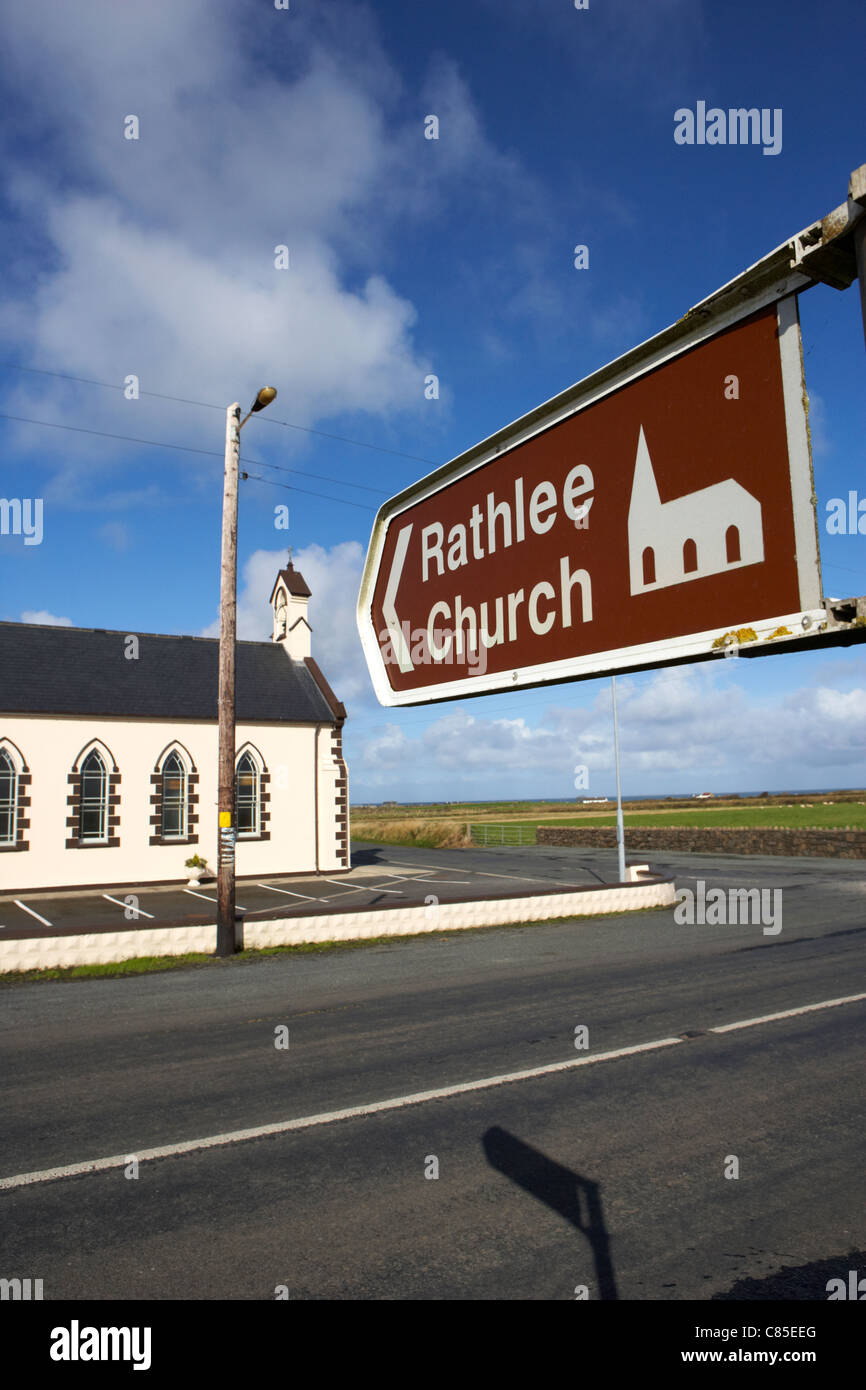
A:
[0,0,866,801]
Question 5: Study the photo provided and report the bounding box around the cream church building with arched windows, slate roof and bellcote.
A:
[0,562,349,892]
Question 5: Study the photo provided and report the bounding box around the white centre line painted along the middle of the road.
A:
[0,994,866,1191]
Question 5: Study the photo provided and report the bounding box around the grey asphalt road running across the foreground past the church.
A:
[0,847,866,1300]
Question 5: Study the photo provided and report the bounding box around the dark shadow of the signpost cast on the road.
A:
[481,1125,619,1300]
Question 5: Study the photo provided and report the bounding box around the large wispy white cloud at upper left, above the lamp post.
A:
[0,0,542,483]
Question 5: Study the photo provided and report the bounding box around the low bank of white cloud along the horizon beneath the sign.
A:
[348,663,866,799]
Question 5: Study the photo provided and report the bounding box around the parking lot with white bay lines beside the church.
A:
[0,845,616,938]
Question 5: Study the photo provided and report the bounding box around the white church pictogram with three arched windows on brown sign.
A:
[628,425,763,594]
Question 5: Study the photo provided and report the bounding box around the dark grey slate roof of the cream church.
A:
[0,623,345,724]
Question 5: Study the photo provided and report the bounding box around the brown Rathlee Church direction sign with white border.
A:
[359,291,827,705]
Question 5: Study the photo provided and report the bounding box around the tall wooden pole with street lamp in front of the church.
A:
[217,386,277,956]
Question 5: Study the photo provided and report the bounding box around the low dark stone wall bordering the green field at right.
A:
[535,826,866,859]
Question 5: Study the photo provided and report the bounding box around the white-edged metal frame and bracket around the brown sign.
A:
[357,165,866,708]
